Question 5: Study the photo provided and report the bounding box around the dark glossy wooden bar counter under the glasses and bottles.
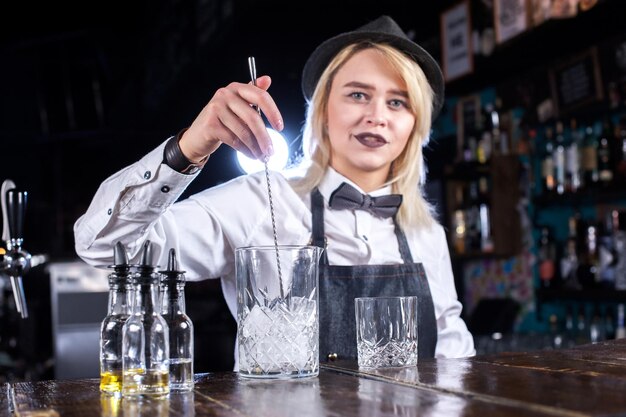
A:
[0,340,626,417]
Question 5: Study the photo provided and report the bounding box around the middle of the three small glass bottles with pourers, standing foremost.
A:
[122,241,170,397]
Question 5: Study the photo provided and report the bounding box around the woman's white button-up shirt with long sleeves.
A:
[74,139,475,357]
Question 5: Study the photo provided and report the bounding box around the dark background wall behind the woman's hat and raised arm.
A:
[0,0,451,258]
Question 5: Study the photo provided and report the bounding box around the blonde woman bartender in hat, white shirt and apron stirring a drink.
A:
[74,16,475,358]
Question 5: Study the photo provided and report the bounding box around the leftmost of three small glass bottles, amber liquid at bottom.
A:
[100,242,133,396]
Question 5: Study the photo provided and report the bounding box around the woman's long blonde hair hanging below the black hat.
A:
[294,42,434,230]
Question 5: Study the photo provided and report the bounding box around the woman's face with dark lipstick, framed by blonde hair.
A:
[327,49,415,191]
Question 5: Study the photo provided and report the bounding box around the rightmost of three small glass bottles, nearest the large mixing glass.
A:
[160,248,194,391]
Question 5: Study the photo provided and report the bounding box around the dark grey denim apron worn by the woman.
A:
[311,189,437,361]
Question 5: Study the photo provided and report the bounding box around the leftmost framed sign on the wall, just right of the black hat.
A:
[441,0,474,81]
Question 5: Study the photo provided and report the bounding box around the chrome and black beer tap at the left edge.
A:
[0,180,31,318]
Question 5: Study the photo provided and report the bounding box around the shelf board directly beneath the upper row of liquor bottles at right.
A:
[533,183,626,207]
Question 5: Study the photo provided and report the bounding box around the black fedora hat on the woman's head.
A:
[302,16,444,120]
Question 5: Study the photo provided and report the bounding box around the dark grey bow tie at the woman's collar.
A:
[328,182,402,217]
